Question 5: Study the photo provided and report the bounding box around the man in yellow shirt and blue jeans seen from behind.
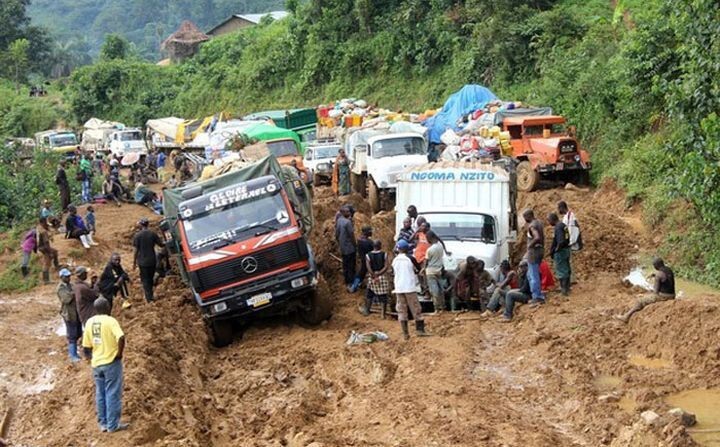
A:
[83,297,128,432]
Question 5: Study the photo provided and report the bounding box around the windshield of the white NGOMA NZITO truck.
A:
[422,213,495,244]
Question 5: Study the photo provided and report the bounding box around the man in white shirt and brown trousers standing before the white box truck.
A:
[392,239,428,340]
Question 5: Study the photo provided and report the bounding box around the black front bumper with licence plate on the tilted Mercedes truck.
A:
[193,268,317,320]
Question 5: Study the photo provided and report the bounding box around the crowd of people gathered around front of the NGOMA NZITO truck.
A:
[335,201,583,338]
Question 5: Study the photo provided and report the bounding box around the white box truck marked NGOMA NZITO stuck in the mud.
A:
[395,160,517,278]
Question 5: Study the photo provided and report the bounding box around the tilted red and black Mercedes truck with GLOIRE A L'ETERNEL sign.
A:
[162,156,331,346]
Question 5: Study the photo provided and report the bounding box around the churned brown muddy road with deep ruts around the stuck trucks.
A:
[0,186,720,447]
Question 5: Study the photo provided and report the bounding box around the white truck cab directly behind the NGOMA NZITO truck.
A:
[345,129,428,212]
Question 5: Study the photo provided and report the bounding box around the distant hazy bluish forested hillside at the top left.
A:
[28,0,285,60]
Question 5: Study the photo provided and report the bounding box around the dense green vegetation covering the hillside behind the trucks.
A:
[0,0,720,282]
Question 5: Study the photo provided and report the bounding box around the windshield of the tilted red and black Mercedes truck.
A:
[183,193,290,253]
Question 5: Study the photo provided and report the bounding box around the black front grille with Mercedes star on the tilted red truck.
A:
[190,239,308,293]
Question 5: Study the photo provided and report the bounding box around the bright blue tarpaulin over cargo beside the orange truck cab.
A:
[423,84,497,143]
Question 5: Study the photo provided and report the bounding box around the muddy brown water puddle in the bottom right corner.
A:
[665,388,720,447]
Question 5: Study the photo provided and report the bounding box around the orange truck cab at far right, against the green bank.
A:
[501,115,592,191]
